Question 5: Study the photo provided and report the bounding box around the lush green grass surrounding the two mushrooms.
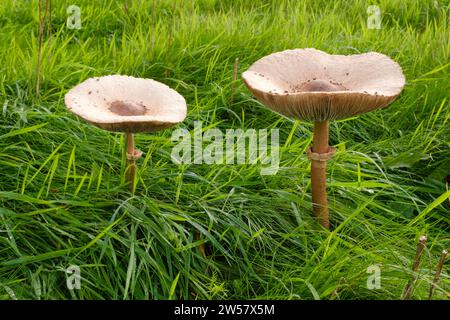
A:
[0,0,450,299]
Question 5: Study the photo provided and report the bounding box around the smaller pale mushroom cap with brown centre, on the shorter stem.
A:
[64,75,187,133]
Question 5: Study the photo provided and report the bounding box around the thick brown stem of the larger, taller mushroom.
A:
[311,121,330,229]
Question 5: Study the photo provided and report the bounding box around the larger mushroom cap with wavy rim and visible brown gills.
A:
[242,48,405,121]
